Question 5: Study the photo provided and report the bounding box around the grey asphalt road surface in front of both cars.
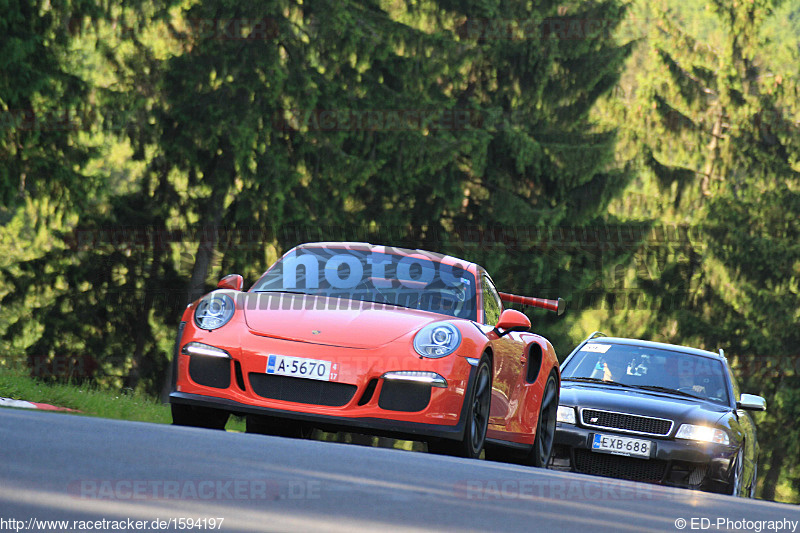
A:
[0,409,800,533]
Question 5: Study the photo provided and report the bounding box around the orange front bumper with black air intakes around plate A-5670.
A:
[170,323,482,439]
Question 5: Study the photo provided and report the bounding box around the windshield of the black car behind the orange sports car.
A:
[561,340,729,405]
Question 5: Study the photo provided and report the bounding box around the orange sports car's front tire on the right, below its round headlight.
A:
[428,355,492,459]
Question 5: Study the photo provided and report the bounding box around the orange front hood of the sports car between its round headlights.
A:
[244,293,448,348]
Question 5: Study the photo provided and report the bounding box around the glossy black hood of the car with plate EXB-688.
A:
[559,381,731,427]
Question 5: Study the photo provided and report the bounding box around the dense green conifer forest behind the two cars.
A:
[0,0,800,502]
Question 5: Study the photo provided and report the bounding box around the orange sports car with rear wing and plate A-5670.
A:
[170,242,563,466]
